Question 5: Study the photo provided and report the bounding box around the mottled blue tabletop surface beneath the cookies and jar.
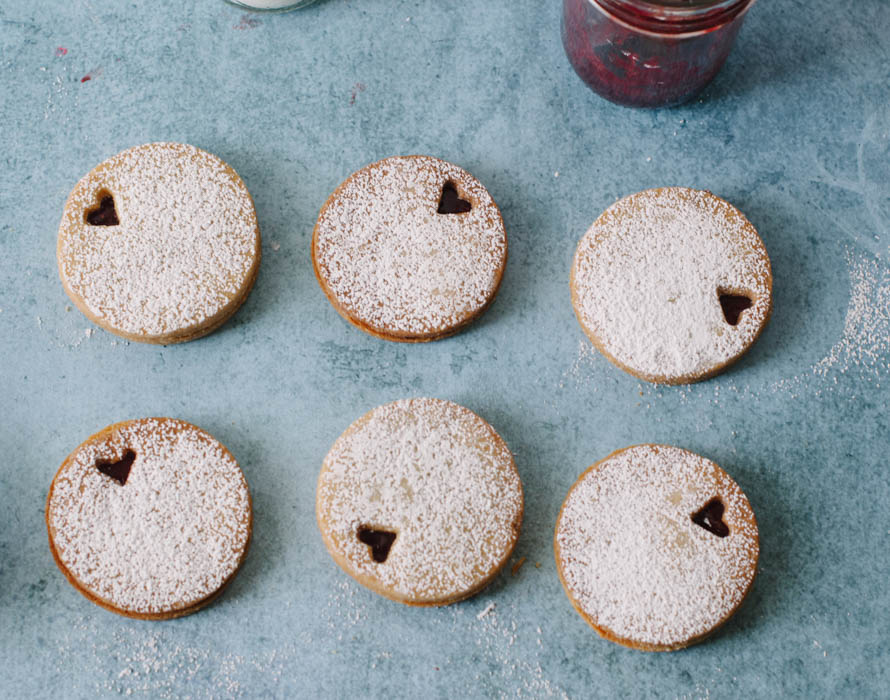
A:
[0,0,890,698]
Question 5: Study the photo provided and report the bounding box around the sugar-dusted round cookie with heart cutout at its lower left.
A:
[315,399,523,606]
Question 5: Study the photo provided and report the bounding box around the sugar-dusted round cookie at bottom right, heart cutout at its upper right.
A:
[554,445,760,651]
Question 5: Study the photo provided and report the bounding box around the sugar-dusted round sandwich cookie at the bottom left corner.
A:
[46,418,252,620]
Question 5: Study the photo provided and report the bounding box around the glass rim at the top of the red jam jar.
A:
[587,0,757,38]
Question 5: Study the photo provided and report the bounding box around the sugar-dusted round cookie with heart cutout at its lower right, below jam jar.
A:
[570,187,773,384]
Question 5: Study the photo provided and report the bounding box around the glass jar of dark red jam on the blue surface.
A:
[562,0,756,107]
